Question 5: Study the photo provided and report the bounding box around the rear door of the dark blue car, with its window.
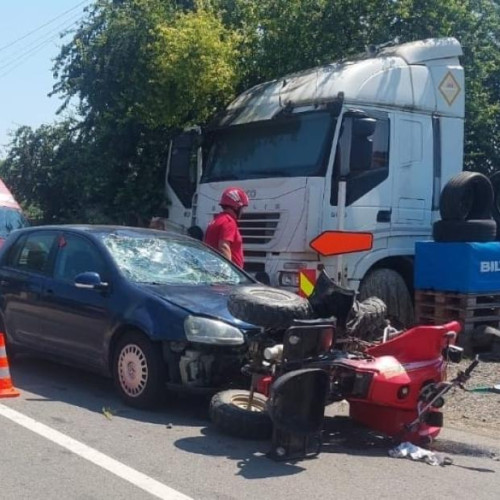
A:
[0,231,57,351]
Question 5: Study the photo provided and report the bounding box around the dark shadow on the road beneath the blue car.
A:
[10,355,208,427]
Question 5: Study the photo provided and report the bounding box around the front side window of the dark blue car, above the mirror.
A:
[54,234,106,283]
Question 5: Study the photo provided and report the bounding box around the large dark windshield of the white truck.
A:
[201,111,336,183]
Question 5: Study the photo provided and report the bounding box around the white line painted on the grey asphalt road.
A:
[0,404,192,500]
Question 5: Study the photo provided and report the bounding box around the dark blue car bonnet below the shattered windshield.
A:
[138,284,255,330]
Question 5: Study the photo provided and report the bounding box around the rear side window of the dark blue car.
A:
[7,232,56,274]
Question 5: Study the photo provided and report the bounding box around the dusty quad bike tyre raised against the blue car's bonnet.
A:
[227,285,312,329]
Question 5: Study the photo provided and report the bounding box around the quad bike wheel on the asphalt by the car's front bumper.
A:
[210,389,273,439]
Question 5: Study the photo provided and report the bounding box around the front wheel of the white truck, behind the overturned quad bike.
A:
[359,269,414,329]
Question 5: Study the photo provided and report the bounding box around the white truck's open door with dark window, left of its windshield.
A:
[165,130,201,229]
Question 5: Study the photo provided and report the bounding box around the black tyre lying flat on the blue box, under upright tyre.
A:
[432,219,497,243]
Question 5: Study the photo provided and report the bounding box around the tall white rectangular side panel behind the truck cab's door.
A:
[392,113,433,226]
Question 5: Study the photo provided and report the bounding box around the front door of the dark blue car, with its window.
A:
[41,233,112,368]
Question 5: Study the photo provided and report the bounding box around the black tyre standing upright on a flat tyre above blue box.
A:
[439,172,493,220]
